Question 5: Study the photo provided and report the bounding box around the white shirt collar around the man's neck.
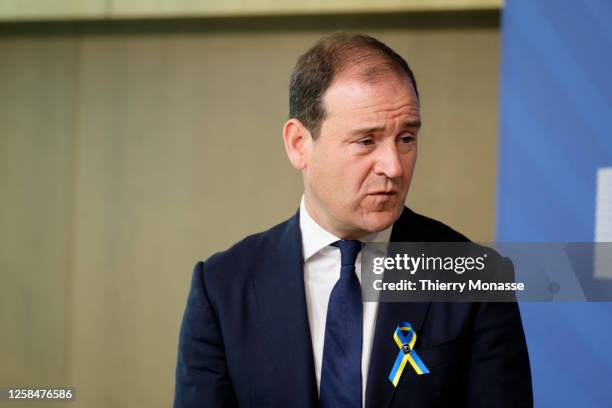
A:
[300,196,393,261]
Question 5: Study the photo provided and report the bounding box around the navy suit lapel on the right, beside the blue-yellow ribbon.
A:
[365,208,431,408]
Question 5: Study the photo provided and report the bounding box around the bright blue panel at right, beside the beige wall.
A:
[497,0,612,407]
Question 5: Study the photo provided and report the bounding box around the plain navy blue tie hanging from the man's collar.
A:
[319,241,363,408]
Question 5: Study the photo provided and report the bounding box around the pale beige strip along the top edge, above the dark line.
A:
[0,0,502,21]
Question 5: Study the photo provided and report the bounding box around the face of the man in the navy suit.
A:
[303,72,420,239]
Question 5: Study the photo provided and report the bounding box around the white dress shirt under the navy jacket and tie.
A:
[300,197,392,406]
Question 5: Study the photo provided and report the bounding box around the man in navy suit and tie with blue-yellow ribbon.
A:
[175,34,532,408]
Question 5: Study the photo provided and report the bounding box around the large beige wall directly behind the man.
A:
[0,14,499,408]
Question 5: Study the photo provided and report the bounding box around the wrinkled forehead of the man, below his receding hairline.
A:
[323,72,420,121]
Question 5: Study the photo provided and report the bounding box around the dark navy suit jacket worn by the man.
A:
[174,208,533,408]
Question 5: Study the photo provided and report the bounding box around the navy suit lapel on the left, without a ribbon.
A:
[255,213,318,407]
